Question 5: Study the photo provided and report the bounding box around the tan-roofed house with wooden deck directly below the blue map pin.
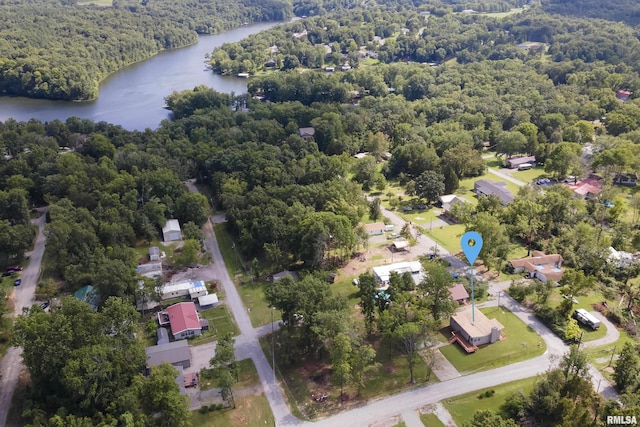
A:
[449,306,504,353]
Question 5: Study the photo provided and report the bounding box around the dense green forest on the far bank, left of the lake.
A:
[0,0,292,100]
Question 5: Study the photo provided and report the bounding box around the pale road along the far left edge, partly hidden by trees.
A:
[0,209,47,426]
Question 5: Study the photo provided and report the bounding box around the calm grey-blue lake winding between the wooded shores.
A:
[0,22,279,130]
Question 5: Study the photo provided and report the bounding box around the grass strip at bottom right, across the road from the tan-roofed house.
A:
[442,377,537,426]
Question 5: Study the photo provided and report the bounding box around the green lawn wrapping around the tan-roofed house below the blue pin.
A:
[440,307,546,374]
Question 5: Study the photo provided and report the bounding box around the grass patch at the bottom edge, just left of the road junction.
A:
[191,394,275,427]
